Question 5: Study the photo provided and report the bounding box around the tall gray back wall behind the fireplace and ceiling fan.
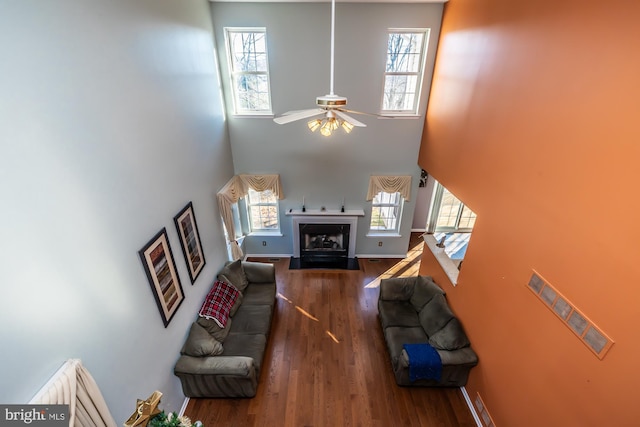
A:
[211,2,443,256]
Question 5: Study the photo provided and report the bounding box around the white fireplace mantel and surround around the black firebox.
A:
[287,209,364,258]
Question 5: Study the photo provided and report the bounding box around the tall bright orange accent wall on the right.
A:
[419,0,640,427]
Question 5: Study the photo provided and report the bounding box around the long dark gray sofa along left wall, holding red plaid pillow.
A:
[174,260,276,398]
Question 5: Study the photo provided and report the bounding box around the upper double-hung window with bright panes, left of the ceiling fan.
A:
[225,28,271,114]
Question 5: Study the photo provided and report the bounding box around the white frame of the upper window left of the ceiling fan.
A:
[224,27,273,116]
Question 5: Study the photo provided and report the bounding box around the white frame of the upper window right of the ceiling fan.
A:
[380,28,431,117]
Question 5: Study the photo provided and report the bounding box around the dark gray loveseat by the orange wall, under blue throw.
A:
[378,276,478,387]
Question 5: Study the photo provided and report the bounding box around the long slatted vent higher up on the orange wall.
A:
[528,270,613,359]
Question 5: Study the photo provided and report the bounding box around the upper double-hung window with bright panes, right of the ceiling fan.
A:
[382,29,429,114]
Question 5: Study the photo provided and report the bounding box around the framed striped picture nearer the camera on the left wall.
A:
[138,228,184,328]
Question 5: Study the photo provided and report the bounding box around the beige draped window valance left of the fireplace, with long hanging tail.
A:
[216,174,284,260]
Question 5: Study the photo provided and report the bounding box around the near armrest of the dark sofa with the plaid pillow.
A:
[173,355,255,376]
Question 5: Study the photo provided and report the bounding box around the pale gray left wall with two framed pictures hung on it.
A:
[0,0,233,425]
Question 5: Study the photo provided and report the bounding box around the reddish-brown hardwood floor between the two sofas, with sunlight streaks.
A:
[185,234,476,427]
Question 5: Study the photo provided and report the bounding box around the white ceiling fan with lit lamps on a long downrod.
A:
[273,0,367,136]
